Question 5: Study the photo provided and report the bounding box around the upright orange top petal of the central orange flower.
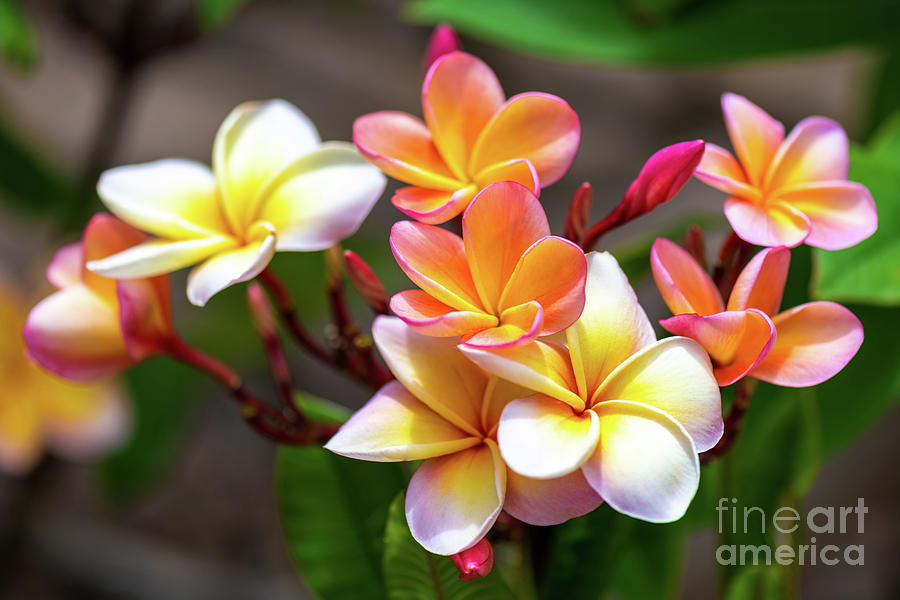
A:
[463,182,550,312]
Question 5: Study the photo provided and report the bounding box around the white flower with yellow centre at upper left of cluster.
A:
[88,100,385,306]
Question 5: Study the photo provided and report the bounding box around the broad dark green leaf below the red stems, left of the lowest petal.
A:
[275,446,406,600]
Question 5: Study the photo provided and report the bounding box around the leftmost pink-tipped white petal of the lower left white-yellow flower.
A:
[325,381,481,462]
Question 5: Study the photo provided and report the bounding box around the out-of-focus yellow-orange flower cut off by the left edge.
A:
[0,274,131,475]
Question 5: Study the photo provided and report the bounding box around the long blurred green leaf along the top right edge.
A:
[404,0,900,65]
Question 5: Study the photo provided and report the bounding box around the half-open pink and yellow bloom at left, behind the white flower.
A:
[24,214,176,381]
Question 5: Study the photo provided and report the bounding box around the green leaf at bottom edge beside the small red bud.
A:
[384,493,513,600]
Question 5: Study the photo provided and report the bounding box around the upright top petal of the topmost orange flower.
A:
[422,52,506,181]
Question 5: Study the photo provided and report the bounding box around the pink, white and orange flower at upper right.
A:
[696,94,878,250]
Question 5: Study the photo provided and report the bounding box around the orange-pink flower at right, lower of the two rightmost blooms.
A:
[650,239,863,387]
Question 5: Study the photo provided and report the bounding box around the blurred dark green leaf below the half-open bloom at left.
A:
[96,359,197,504]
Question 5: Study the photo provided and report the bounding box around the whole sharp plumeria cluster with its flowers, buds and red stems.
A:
[25,24,876,579]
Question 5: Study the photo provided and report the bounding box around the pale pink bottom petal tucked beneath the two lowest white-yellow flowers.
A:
[503,469,603,525]
